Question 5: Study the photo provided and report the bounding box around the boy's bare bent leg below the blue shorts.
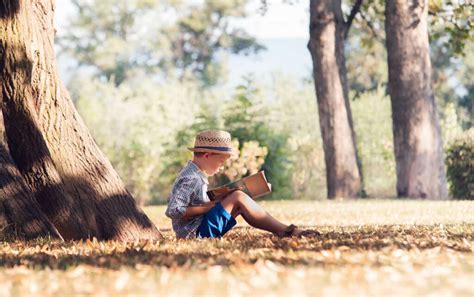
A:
[221,191,288,234]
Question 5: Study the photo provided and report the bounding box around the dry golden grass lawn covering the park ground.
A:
[0,200,474,296]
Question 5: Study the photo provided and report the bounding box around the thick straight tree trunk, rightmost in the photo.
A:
[385,0,448,199]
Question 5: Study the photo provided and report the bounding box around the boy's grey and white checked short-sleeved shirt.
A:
[165,161,209,238]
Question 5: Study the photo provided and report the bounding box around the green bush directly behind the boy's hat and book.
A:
[167,81,291,198]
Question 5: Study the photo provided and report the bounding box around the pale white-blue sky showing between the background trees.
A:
[55,0,312,87]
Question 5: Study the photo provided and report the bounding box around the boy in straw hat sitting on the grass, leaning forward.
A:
[166,130,307,238]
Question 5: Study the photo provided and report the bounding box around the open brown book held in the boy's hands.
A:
[207,171,272,200]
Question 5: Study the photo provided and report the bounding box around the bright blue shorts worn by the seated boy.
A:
[196,203,237,238]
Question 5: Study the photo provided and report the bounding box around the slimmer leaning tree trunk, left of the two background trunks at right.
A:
[308,0,362,198]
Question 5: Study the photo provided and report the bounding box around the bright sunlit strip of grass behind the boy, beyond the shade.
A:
[145,199,474,229]
